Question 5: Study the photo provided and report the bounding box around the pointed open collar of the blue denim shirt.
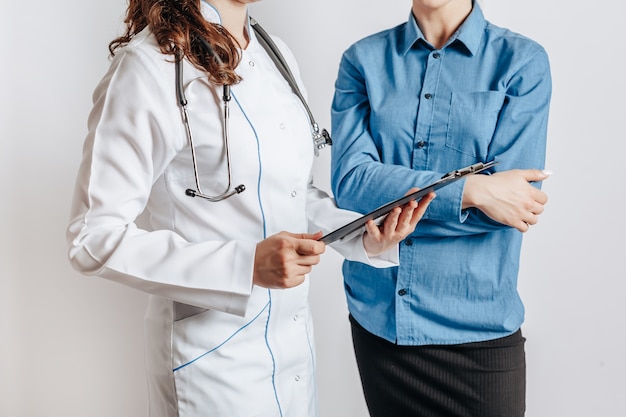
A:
[402,2,487,55]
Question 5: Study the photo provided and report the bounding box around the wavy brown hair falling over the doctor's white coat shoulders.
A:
[109,0,241,85]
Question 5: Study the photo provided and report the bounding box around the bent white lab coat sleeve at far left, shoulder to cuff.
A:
[67,47,256,315]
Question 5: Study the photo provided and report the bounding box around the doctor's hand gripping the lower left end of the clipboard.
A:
[253,232,326,288]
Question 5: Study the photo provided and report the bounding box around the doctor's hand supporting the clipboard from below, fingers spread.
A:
[363,188,435,257]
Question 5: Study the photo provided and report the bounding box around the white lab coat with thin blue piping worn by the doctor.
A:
[68,3,397,417]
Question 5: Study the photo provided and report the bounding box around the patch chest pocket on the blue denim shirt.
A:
[446,91,506,159]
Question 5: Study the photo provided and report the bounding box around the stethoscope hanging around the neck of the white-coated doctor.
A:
[175,18,332,202]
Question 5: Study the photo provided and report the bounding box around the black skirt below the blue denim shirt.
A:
[350,316,526,417]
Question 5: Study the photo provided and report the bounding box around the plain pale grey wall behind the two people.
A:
[0,0,626,417]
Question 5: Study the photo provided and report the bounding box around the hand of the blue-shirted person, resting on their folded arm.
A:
[463,169,550,232]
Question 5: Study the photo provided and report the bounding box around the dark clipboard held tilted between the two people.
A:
[318,161,497,245]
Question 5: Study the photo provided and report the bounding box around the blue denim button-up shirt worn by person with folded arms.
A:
[331,4,551,345]
